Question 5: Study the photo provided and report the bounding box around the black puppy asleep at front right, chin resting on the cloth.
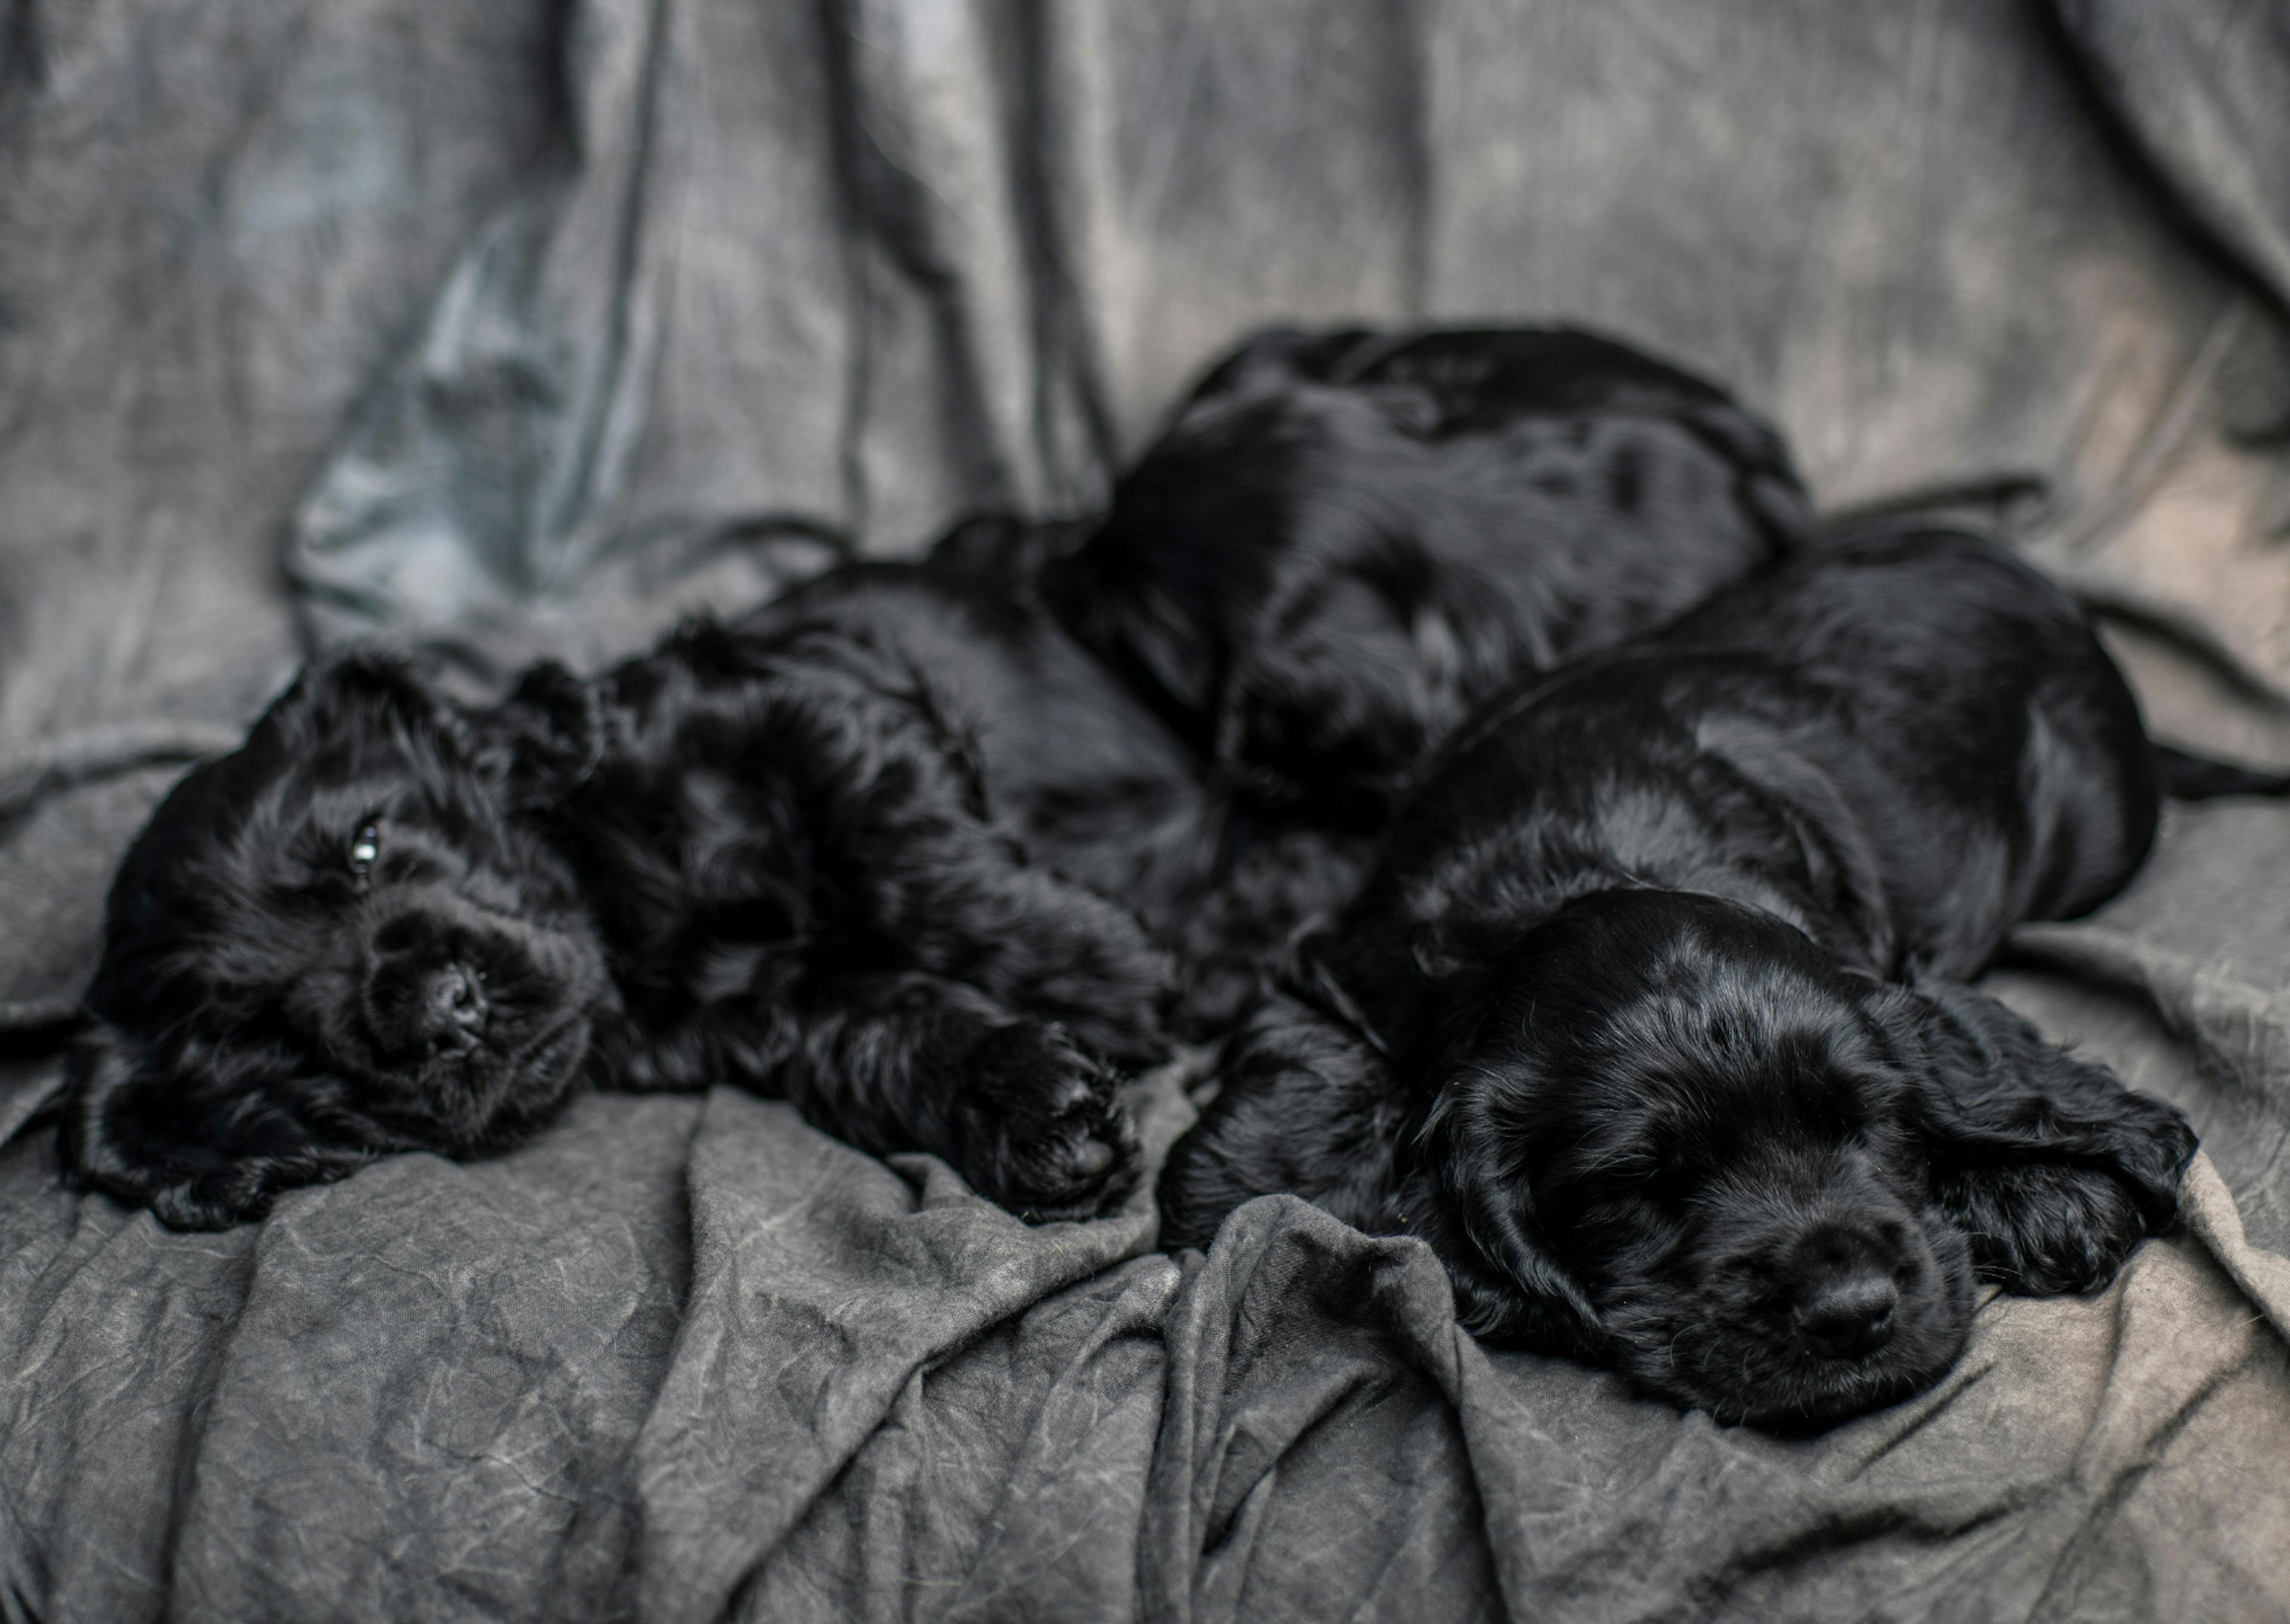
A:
[1161,531,2281,1425]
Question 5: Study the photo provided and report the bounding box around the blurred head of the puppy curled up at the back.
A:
[1047,362,1438,811]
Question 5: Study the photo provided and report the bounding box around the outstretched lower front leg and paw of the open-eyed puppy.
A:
[779,976,1138,1221]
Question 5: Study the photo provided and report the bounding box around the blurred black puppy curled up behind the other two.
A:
[1042,327,1809,1036]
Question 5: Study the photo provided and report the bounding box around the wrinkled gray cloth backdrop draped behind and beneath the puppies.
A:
[0,0,2290,1624]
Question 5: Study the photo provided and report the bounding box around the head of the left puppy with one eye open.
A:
[62,655,609,1228]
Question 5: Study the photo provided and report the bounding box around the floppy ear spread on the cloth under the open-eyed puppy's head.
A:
[57,1019,371,1230]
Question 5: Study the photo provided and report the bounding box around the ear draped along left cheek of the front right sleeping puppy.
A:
[1399,1077,1608,1360]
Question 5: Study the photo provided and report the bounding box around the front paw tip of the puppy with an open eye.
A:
[960,1026,1138,1223]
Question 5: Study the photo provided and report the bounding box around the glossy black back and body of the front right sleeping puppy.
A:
[1356,531,2157,989]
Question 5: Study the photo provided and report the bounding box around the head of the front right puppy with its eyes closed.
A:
[1401,891,1972,1427]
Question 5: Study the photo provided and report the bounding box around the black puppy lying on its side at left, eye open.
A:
[62,526,1197,1228]
